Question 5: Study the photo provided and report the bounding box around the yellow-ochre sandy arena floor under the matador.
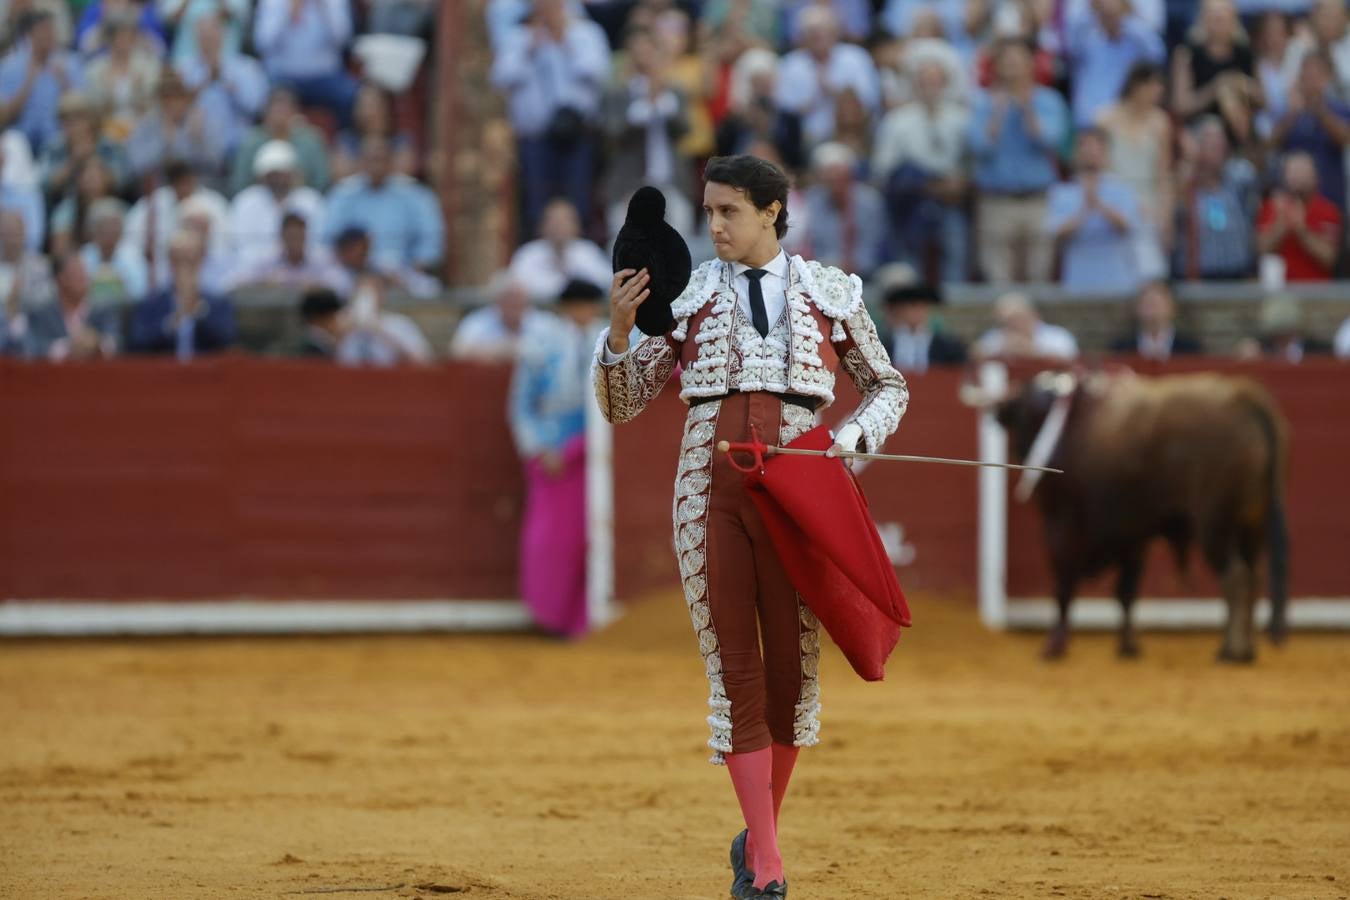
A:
[0,596,1350,900]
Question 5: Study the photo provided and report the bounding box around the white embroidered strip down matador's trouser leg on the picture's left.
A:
[674,401,732,765]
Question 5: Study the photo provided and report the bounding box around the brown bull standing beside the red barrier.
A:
[996,372,1288,663]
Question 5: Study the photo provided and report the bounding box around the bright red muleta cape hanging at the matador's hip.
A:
[732,425,910,681]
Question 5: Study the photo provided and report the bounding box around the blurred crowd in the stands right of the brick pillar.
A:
[487,0,1350,364]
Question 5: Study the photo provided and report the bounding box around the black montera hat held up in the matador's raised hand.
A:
[614,188,694,336]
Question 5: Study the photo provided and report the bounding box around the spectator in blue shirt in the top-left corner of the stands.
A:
[0,9,84,154]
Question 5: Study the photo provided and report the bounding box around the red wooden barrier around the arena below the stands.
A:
[0,359,1350,599]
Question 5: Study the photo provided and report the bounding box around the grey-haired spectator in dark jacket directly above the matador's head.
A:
[717,47,805,169]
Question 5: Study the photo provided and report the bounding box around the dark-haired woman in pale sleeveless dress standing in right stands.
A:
[1100,62,1176,278]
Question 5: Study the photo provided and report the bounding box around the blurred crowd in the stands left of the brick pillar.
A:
[0,0,446,363]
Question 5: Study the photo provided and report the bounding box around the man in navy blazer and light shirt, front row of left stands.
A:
[130,229,235,362]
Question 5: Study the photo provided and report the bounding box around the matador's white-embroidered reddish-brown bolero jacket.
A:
[593,256,910,452]
